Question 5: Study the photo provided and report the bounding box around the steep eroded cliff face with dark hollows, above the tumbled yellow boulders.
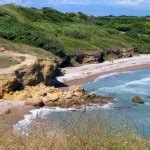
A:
[0,60,57,98]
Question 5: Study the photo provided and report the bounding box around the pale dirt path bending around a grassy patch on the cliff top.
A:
[0,47,37,75]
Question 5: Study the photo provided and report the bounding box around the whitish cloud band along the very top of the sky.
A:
[0,0,150,6]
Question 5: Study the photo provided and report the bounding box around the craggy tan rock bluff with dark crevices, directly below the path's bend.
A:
[15,60,57,87]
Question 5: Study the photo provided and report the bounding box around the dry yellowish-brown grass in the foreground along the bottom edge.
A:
[0,111,150,150]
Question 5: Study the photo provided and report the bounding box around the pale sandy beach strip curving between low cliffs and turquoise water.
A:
[57,54,150,86]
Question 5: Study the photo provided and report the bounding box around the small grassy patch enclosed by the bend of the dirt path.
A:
[0,56,19,68]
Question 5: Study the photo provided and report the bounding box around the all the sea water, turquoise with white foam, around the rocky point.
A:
[14,69,150,139]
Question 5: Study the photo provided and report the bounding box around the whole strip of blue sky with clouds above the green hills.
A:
[0,0,150,16]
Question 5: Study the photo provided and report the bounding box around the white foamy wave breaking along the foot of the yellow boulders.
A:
[13,103,113,135]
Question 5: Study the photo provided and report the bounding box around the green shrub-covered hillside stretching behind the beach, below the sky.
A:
[0,5,150,57]
